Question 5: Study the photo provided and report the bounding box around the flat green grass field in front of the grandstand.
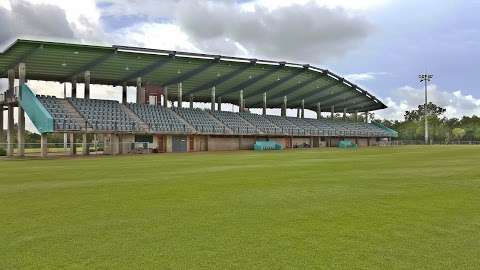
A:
[0,146,480,269]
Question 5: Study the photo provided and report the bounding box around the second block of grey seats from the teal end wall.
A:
[69,98,143,132]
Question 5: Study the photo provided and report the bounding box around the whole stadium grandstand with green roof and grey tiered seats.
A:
[0,39,396,156]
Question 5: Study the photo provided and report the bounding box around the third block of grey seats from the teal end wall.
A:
[127,103,194,134]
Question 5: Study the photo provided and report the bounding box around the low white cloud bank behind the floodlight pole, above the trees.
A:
[377,84,480,120]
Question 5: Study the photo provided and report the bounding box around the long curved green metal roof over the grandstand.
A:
[0,39,386,112]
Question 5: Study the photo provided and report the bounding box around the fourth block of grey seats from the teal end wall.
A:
[173,108,230,134]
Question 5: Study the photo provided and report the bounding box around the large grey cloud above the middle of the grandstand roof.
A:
[175,1,373,63]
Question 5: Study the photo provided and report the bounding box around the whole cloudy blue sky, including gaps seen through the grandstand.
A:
[0,0,480,131]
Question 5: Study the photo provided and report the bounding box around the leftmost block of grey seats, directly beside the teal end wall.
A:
[37,95,82,130]
